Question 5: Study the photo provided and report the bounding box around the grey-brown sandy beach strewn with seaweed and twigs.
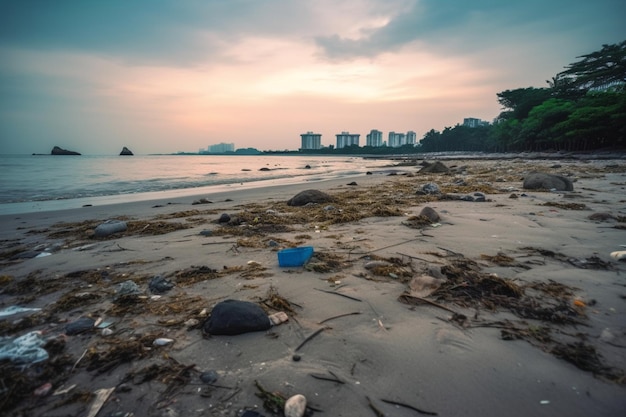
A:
[0,159,626,416]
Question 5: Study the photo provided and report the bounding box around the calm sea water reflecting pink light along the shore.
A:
[0,155,390,214]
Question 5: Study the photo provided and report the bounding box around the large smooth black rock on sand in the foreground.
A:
[203,300,272,335]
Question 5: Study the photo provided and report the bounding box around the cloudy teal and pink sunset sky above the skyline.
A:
[0,0,626,155]
